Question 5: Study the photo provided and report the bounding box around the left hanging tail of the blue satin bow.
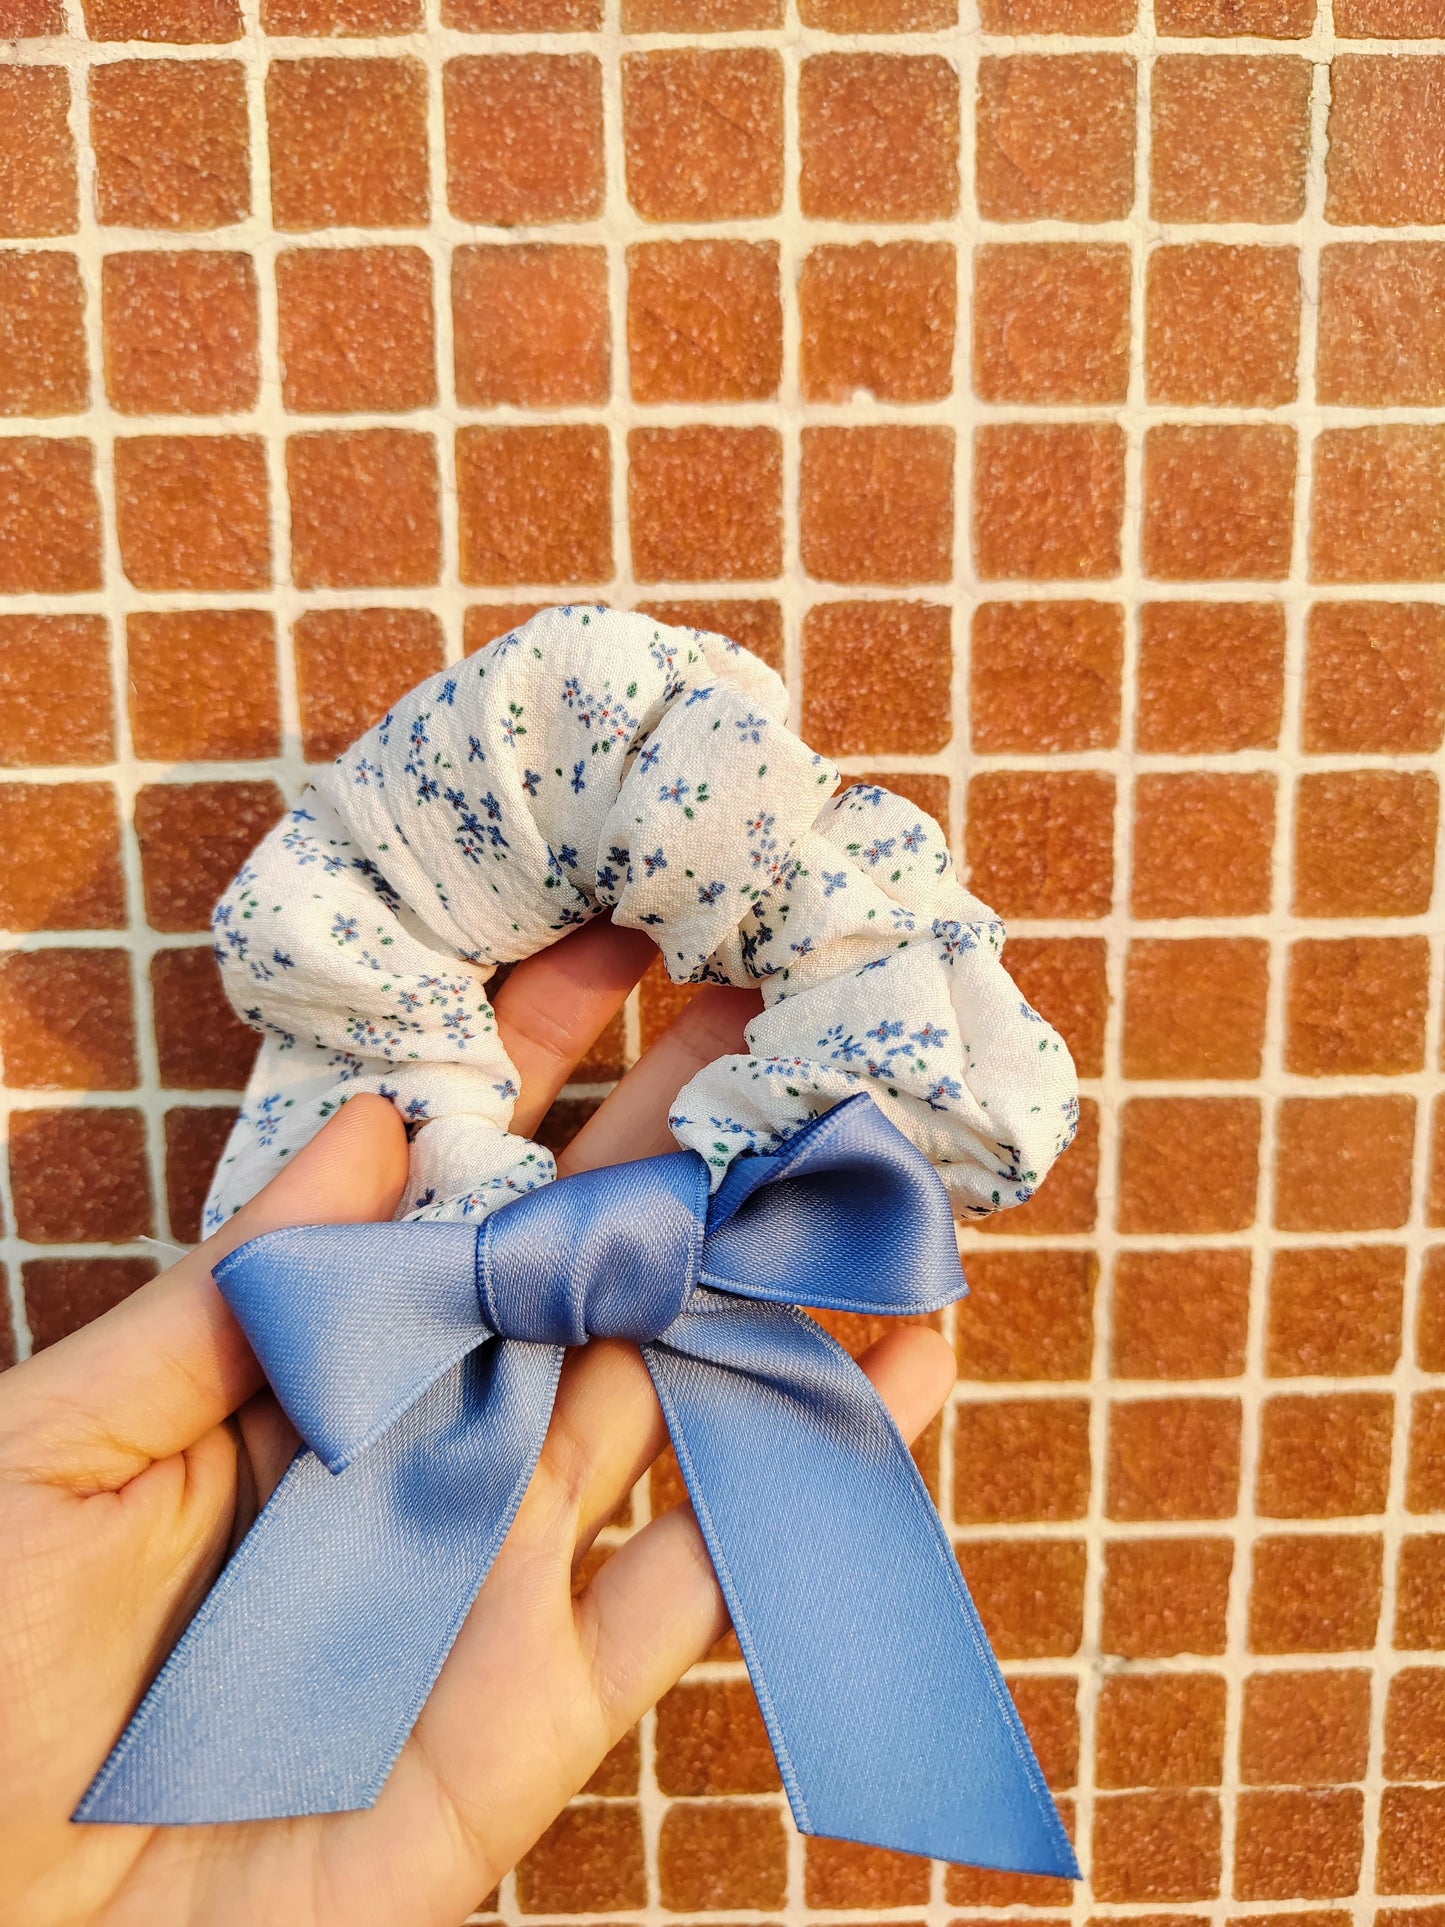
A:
[73,1341,563,1825]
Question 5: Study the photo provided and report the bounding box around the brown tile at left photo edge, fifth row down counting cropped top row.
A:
[0,615,116,769]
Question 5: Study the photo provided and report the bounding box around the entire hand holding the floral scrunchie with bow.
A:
[0,925,954,1927]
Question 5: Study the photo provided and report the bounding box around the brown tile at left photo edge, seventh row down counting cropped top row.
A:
[0,950,139,1091]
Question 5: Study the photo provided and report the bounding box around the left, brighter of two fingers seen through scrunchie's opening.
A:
[493,919,657,1137]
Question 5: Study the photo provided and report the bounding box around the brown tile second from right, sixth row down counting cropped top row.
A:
[967,769,1114,917]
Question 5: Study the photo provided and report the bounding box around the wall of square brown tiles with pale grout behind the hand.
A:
[0,0,1445,1927]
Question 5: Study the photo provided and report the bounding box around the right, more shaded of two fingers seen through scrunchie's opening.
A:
[557,985,763,1177]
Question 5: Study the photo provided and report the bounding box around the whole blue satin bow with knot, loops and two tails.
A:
[75,1095,1077,1875]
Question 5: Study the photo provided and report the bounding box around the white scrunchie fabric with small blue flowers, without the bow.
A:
[206,607,1079,1231]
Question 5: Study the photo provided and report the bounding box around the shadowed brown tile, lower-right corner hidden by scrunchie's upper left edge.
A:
[135,782,285,931]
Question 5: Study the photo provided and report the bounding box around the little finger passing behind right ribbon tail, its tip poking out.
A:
[576,1326,954,1734]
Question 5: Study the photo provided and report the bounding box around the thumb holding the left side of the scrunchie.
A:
[0,1096,407,1491]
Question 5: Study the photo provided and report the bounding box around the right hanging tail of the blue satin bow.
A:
[644,1289,1079,1879]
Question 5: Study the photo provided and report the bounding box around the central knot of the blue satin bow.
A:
[476,1150,707,1345]
